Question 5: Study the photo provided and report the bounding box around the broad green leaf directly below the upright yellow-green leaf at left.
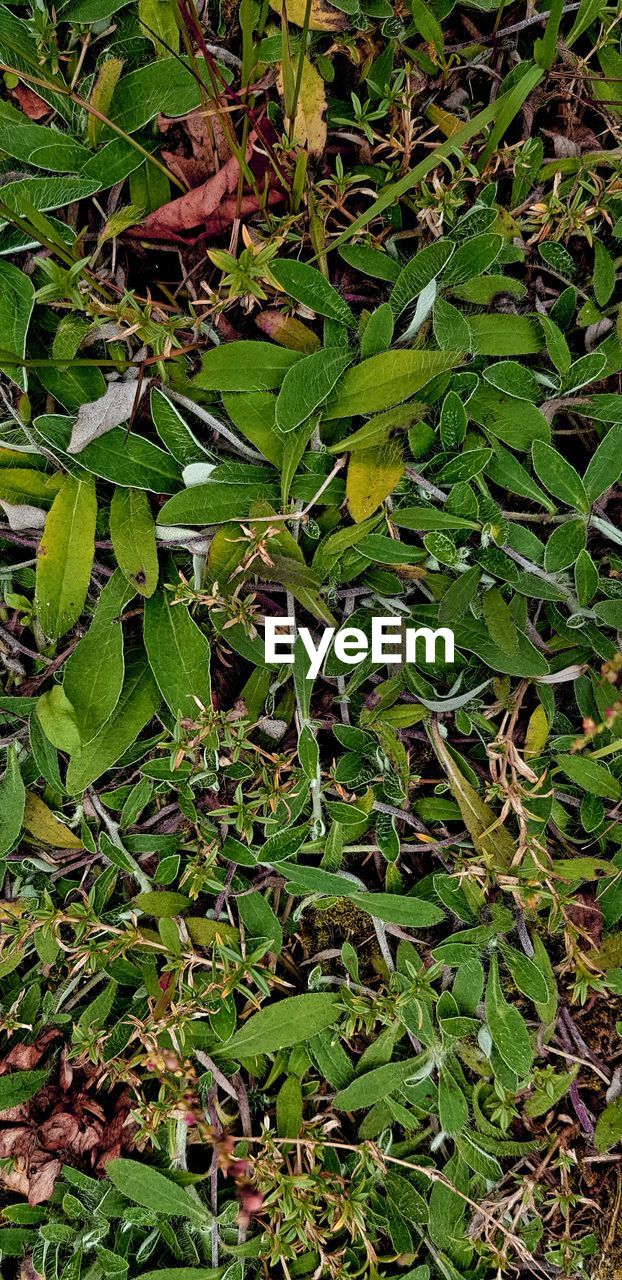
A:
[63,570,133,742]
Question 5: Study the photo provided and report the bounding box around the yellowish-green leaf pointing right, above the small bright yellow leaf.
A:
[324,351,462,419]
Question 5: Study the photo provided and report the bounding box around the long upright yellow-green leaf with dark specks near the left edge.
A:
[35,476,97,640]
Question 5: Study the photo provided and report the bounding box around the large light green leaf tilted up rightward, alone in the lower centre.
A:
[223,992,339,1061]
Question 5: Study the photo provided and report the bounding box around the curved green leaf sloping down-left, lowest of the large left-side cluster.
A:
[67,650,160,795]
